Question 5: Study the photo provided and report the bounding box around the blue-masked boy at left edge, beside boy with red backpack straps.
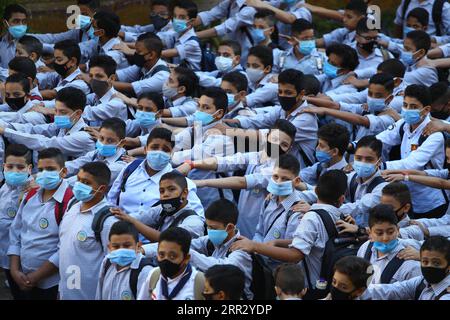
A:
[0,144,33,297]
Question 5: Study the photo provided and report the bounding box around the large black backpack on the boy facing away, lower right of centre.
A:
[303,209,360,300]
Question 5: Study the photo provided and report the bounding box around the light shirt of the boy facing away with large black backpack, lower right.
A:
[290,204,340,287]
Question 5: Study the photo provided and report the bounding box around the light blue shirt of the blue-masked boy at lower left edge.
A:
[0,183,24,269]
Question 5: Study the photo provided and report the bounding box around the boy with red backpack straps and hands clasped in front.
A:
[8,148,73,300]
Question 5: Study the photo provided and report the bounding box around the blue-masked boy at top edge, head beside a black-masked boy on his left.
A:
[162,0,202,71]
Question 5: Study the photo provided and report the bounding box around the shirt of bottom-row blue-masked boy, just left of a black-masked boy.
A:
[95,253,153,300]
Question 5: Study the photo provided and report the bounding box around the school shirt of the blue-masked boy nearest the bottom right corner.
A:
[357,240,422,285]
